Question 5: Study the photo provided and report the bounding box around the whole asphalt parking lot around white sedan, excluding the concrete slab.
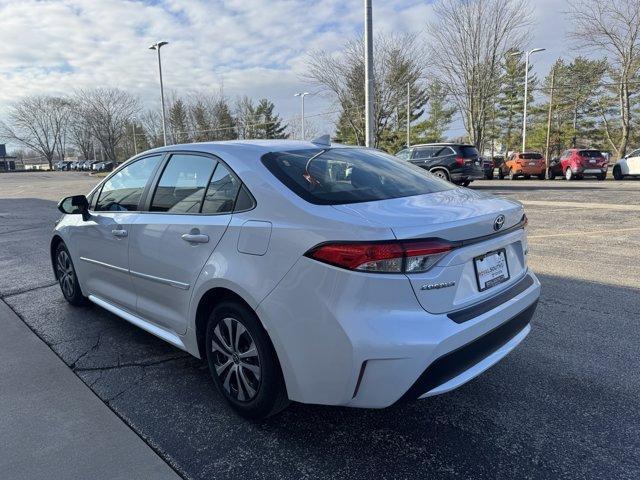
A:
[0,172,640,479]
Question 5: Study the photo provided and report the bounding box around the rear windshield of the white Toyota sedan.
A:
[262,148,456,205]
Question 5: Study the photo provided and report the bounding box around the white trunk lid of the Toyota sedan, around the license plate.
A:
[334,188,527,313]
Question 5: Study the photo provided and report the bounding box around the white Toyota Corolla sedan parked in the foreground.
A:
[50,139,540,417]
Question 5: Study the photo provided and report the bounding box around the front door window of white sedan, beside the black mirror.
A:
[96,155,162,212]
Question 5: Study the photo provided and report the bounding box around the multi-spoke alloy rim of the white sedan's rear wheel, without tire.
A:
[211,317,261,402]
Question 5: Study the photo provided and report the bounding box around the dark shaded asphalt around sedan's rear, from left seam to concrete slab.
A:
[6,275,640,480]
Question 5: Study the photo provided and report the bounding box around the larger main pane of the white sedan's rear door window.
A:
[150,154,216,213]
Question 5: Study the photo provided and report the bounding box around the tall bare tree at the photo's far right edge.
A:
[567,0,640,156]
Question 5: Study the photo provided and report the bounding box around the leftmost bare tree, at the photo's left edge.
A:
[0,96,70,168]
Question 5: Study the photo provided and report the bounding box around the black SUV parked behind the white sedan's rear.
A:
[396,143,484,187]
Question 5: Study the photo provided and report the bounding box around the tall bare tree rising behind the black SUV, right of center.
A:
[428,0,532,147]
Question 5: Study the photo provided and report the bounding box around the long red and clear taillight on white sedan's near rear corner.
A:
[305,239,459,273]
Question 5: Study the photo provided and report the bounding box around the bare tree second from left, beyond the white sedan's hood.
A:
[76,88,139,162]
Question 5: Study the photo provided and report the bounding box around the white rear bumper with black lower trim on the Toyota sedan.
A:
[257,253,540,408]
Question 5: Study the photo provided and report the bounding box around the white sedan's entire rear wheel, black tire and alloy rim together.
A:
[206,301,289,419]
